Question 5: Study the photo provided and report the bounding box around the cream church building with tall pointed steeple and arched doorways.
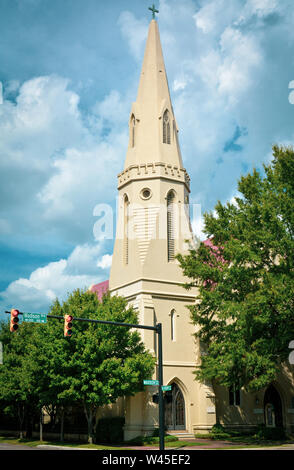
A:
[92,19,294,440]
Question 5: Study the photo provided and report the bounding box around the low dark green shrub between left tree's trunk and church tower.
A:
[96,416,125,444]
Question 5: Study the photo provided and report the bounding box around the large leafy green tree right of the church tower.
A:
[178,146,294,391]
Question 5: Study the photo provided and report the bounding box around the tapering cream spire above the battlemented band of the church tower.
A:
[125,19,183,170]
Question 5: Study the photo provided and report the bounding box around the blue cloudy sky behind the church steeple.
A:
[0,0,294,315]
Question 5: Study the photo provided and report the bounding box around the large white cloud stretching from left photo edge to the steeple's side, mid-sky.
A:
[0,75,130,243]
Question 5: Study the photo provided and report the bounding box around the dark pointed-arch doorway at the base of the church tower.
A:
[164,383,186,430]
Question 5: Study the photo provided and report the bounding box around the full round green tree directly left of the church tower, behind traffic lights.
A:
[32,289,155,442]
